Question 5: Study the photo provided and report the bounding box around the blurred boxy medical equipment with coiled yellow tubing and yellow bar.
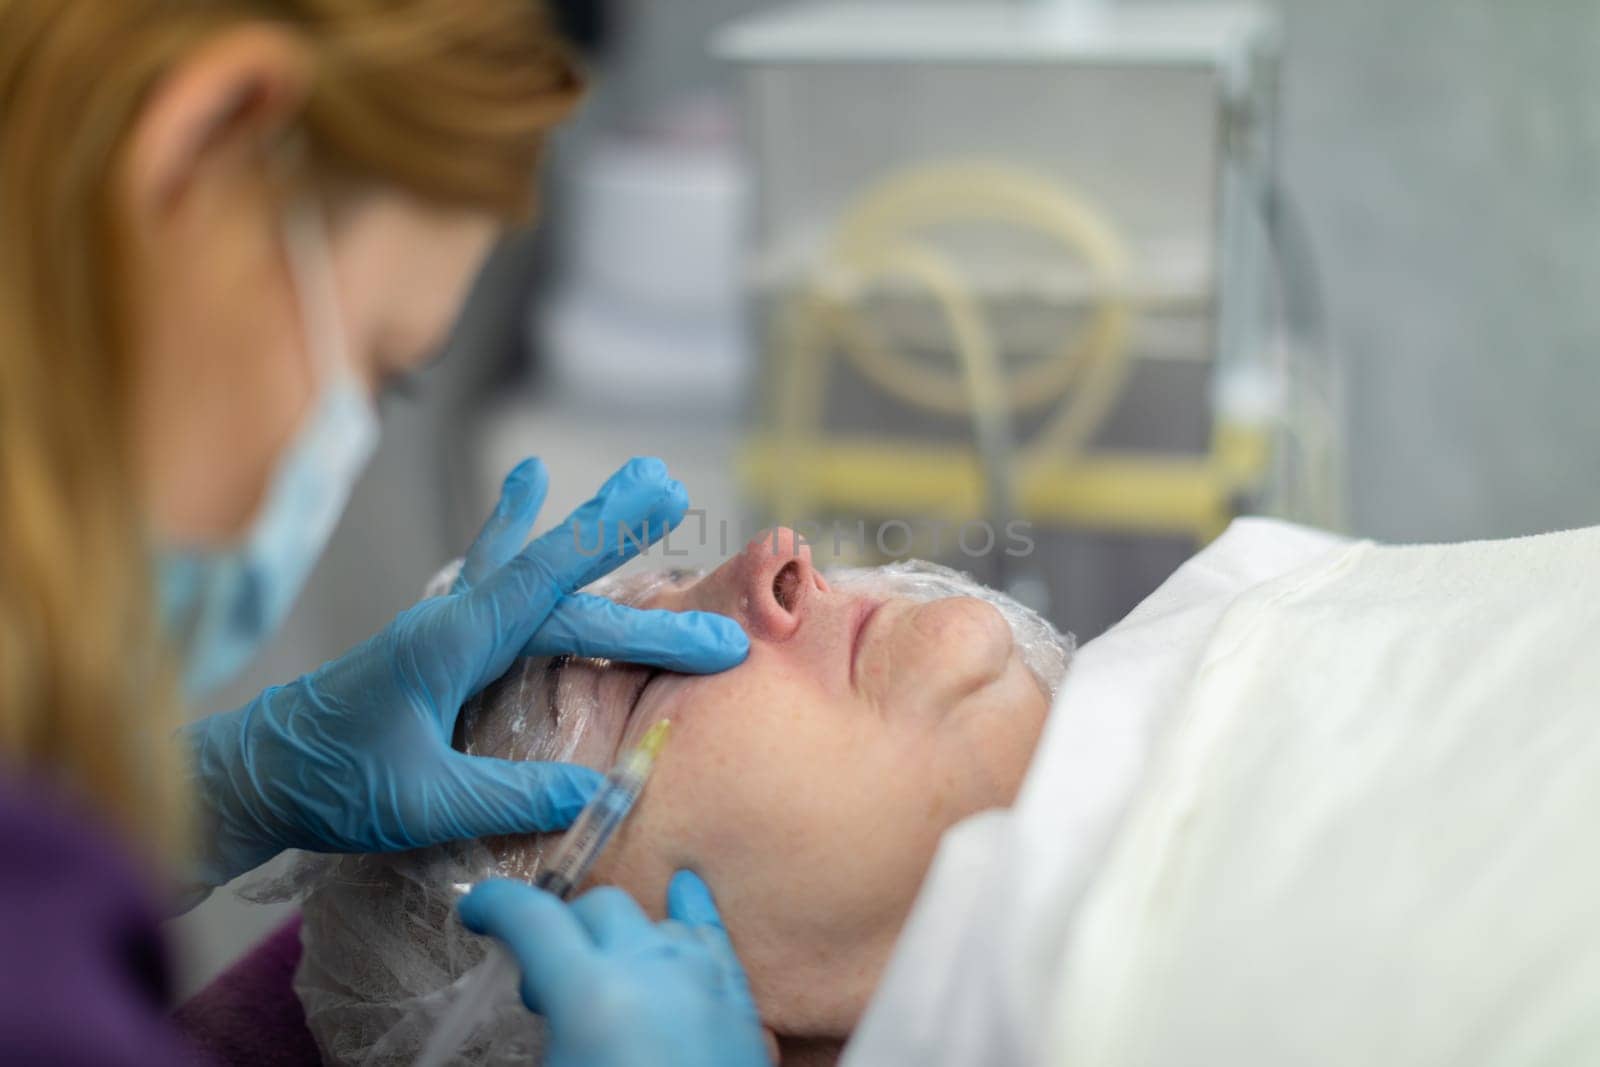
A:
[715,3,1339,632]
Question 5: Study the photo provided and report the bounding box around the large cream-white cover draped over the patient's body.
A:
[1049,528,1600,1067]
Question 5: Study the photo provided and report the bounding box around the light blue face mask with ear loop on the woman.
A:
[157,205,378,697]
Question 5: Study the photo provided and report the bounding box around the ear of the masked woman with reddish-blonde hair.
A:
[123,22,312,214]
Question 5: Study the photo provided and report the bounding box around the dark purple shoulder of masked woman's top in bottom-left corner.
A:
[0,774,202,1065]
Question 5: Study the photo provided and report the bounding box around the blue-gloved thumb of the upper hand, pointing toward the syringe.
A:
[440,752,603,840]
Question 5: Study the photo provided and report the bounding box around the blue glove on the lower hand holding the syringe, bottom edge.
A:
[459,870,771,1067]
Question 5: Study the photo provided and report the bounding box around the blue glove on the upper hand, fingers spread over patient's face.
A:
[184,459,749,885]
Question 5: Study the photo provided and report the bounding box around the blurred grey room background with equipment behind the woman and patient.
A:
[176,0,1600,992]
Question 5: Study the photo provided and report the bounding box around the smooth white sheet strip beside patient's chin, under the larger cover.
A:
[845,520,1347,1067]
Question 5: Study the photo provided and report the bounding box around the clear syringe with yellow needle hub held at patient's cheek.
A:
[416,718,672,1067]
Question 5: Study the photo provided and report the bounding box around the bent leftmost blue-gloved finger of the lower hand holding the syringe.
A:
[456,878,600,1019]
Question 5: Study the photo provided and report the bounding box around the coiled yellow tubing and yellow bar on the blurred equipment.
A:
[744,163,1266,539]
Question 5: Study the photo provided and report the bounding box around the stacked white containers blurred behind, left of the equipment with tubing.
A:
[530,101,749,413]
